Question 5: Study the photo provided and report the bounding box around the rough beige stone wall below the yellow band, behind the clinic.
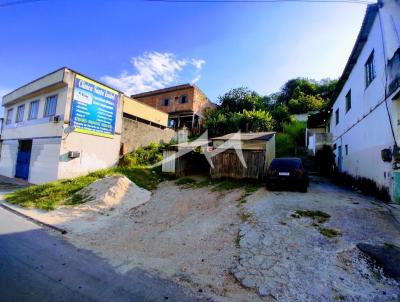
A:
[121,117,176,154]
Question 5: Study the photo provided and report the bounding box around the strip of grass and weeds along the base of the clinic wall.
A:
[6,144,170,211]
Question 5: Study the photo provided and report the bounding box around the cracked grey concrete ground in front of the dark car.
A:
[234,180,400,301]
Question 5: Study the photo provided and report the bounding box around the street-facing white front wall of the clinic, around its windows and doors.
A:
[0,79,68,184]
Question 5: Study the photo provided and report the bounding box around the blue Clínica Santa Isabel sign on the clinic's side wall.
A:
[71,75,118,138]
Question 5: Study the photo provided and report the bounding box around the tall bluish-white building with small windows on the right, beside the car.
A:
[328,0,400,200]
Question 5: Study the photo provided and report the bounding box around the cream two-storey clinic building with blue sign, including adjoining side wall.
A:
[0,68,175,184]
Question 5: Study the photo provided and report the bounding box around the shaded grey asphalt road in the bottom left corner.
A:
[0,207,206,302]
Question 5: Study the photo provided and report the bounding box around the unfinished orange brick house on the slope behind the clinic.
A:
[132,84,216,133]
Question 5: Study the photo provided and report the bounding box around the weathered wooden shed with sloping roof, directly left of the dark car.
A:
[211,132,275,180]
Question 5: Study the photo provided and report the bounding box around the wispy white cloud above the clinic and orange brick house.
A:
[102,51,205,95]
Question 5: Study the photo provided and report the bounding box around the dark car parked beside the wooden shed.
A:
[267,157,308,192]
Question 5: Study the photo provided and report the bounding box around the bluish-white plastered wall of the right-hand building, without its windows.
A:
[330,1,400,196]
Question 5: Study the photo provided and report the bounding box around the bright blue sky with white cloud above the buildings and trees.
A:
[0,0,372,109]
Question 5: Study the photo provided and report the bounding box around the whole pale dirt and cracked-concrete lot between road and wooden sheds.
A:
[3,176,400,301]
